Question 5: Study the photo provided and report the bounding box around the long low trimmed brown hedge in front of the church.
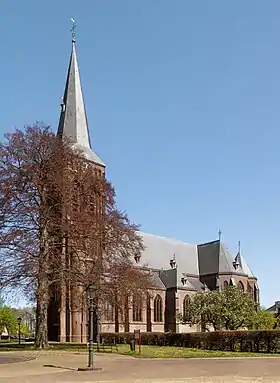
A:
[102,330,280,353]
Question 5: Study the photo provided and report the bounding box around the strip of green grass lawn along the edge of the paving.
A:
[0,343,280,358]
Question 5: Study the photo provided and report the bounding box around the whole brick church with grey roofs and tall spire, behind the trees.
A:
[48,36,259,342]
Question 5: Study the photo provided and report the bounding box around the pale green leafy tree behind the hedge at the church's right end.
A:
[181,287,256,330]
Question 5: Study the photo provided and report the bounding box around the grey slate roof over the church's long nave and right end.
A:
[137,232,253,291]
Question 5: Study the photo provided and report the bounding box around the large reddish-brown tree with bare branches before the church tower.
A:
[0,125,152,347]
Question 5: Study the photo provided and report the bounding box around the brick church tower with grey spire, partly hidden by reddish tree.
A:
[48,35,105,342]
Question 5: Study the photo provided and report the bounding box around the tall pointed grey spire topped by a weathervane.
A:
[57,19,105,166]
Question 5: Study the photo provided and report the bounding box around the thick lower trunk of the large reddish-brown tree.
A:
[35,277,49,348]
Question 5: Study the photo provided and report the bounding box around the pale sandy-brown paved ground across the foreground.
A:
[0,352,280,383]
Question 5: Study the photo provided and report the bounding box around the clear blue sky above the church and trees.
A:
[0,0,280,305]
